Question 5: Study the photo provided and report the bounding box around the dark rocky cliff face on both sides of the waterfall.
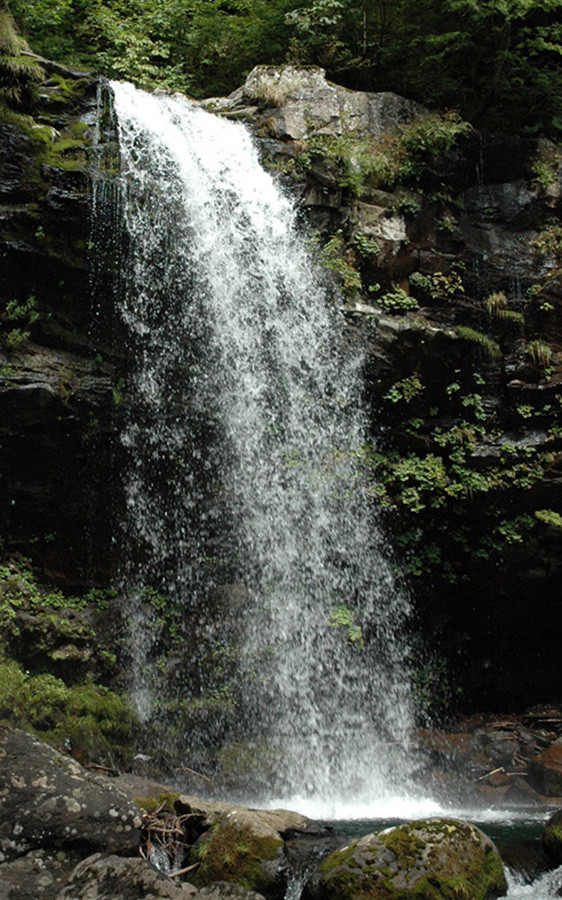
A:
[0,67,562,706]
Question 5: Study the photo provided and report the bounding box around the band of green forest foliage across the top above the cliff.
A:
[4,0,562,135]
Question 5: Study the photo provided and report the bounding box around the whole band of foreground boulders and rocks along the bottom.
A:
[0,726,548,900]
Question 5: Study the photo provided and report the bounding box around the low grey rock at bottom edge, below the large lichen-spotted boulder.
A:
[57,853,196,900]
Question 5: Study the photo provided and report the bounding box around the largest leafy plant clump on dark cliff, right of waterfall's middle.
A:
[356,334,556,584]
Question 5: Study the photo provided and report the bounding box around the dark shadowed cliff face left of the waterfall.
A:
[0,64,123,584]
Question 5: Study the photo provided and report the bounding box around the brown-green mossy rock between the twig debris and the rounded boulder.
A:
[191,809,283,897]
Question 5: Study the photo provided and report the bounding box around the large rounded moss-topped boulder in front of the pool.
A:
[312,819,507,900]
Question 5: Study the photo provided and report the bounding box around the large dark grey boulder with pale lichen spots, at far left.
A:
[0,726,142,859]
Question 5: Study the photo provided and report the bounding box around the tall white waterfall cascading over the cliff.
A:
[112,83,411,803]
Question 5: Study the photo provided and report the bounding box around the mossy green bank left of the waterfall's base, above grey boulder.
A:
[0,561,137,766]
